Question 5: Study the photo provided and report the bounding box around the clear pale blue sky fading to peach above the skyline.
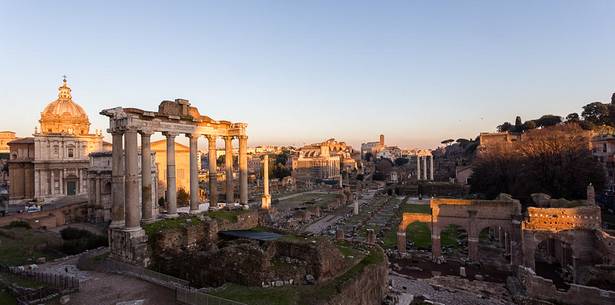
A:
[0,0,615,147]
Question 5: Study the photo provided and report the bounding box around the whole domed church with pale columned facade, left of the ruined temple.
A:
[9,80,103,202]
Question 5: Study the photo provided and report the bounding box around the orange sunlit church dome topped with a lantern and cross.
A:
[39,79,90,134]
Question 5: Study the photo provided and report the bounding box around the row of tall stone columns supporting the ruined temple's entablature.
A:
[109,129,248,230]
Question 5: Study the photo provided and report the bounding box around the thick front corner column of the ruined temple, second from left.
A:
[124,129,141,231]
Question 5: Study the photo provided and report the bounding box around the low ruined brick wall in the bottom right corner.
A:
[517,266,615,305]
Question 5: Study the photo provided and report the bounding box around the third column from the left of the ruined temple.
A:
[140,131,154,223]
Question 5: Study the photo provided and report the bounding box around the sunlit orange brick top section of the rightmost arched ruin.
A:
[523,206,602,232]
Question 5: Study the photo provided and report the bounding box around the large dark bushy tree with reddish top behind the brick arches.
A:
[470,124,605,203]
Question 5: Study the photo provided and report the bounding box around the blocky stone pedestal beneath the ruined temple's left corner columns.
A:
[109,228,150,267]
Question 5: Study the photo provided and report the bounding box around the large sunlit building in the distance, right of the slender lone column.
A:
[292,139,357,182]
